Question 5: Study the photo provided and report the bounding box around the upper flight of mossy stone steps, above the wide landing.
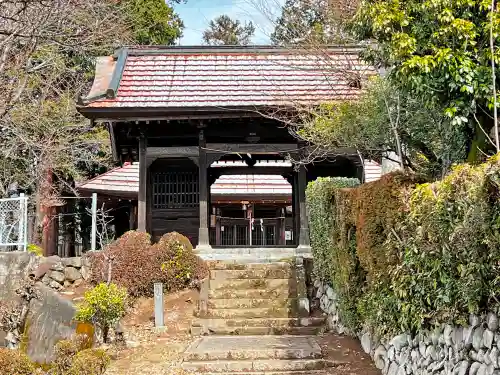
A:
[192,257,324,335]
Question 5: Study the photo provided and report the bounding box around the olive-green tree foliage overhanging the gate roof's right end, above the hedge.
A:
[298,78,466,176]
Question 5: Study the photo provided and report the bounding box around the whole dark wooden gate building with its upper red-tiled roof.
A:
[79,47,375,254]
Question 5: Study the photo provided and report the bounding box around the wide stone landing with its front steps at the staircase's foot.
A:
[182,336,345,375]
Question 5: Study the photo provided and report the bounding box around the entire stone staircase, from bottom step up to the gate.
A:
[182,257,337,375]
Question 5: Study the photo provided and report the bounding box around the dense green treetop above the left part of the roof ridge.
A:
[125,0,184,45]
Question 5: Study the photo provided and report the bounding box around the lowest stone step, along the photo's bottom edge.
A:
[181,359,333,373]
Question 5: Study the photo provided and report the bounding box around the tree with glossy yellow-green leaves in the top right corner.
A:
[353,0,500,161]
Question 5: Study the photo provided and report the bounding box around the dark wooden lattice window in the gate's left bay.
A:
[153,171,199,209]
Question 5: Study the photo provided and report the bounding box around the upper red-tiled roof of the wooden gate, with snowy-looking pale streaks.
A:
[82,47,375,108]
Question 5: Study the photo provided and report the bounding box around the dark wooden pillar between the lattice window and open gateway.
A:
[196,130,211,249]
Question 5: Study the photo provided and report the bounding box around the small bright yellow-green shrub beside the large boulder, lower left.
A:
[75,283,127,342]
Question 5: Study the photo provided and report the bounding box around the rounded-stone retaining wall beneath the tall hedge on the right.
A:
[314,280,500,375]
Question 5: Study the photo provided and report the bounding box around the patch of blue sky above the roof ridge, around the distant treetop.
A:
[174,0,284,45]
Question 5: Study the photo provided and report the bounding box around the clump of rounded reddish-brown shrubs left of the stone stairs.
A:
[90,231,208,297]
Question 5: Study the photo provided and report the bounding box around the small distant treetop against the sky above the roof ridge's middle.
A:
[203,14,255,46]
